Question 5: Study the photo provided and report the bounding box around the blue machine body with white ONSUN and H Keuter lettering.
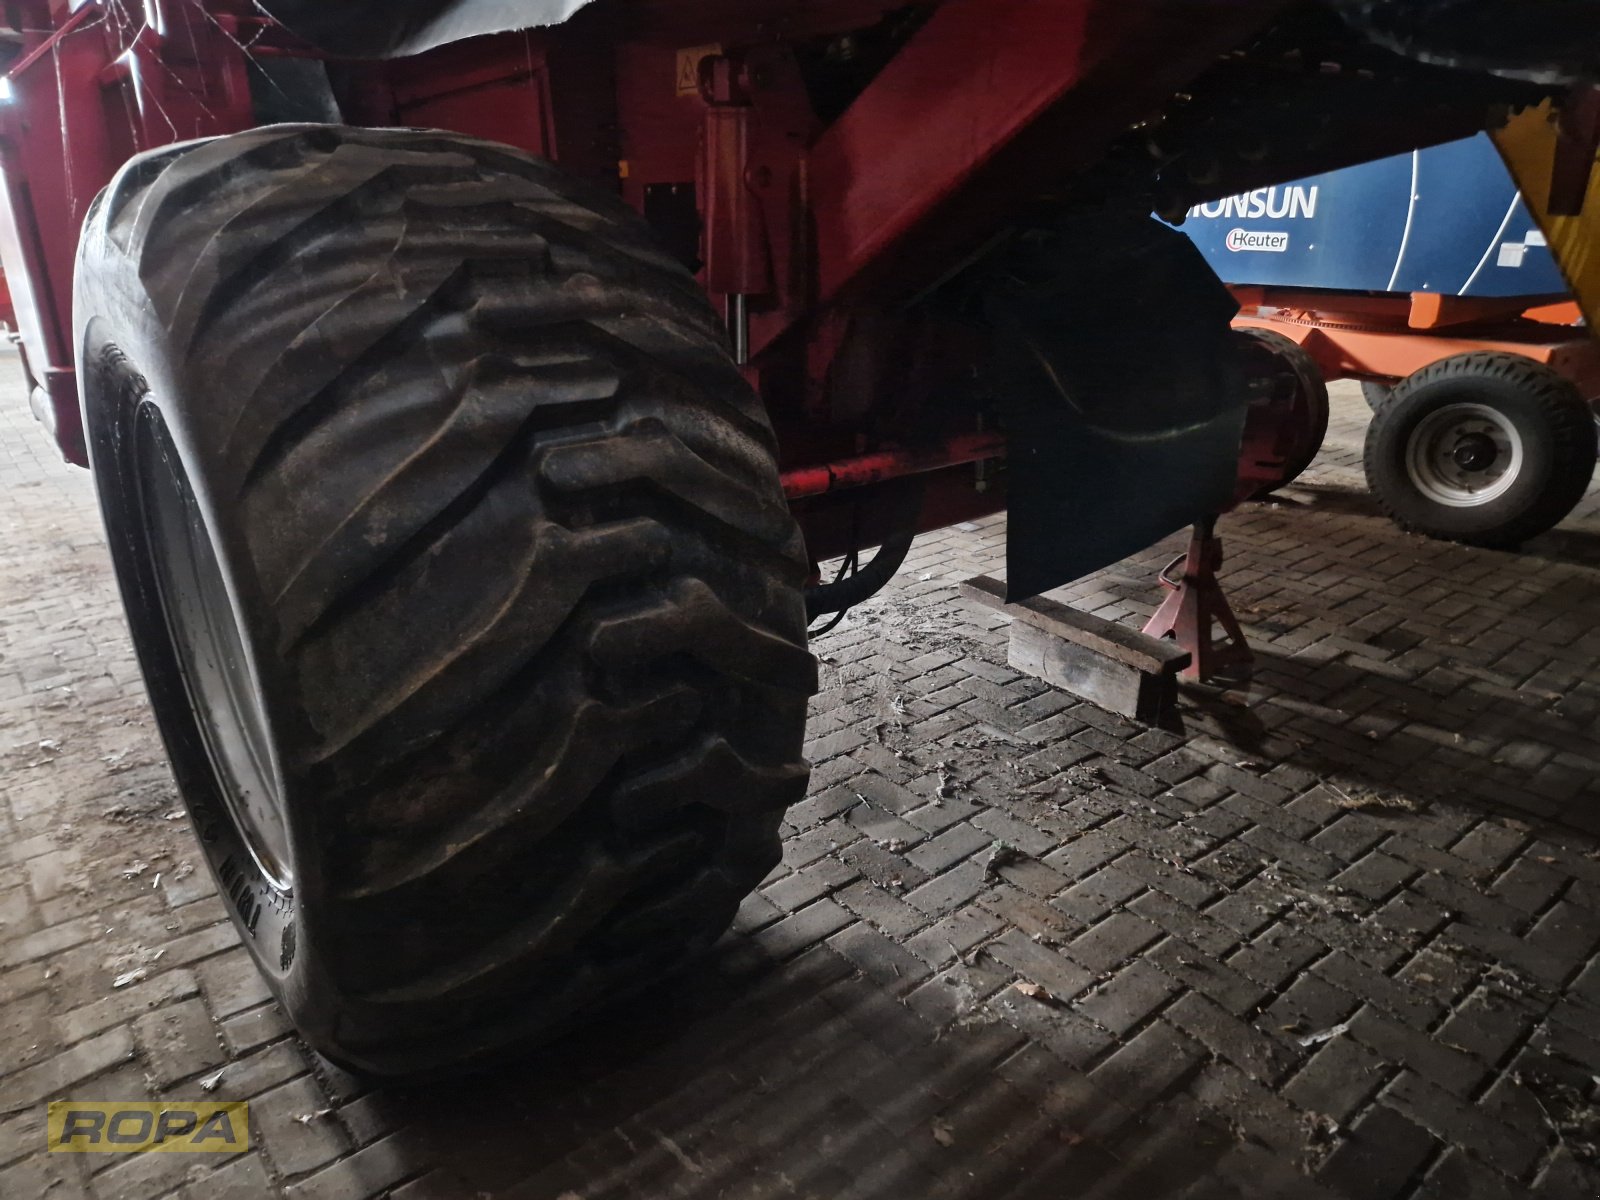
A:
[1179,134,1566,296]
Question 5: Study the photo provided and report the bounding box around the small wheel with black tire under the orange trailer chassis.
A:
[1363,350,1595,549]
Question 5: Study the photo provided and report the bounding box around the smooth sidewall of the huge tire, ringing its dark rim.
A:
[75,214,336,1042]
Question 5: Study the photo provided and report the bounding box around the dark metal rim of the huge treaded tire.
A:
[134,405,293,891]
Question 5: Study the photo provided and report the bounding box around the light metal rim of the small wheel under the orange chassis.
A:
[1406,403,1523,509]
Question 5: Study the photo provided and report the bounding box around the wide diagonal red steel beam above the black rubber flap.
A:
[774,0,1286,349]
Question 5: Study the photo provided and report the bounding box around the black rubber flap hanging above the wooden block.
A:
[982,213,1248,600]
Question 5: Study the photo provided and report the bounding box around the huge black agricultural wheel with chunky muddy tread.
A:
[77,126,814,1077]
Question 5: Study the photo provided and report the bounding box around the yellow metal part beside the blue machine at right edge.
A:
[1491,101,1600,330]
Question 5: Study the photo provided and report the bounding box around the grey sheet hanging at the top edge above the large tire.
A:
[258,0,589,58]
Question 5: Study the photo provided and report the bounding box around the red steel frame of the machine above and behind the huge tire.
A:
[0,0,1282,558]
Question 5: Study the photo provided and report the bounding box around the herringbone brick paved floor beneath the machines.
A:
[0,352,1600,1200]
